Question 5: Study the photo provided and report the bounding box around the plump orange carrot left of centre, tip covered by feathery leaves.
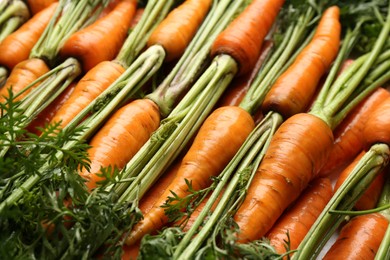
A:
[80,99,160,190]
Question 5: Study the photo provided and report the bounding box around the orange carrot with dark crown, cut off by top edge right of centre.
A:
[211,0,284,75]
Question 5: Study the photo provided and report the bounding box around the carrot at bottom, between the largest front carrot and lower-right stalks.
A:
[267,178,333,254]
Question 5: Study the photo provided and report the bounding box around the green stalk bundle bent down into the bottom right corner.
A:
[293,144,390,259]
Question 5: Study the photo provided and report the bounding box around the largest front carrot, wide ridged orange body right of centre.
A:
[234,113,333,242]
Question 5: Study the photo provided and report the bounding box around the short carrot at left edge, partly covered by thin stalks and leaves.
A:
[0,59,49,102]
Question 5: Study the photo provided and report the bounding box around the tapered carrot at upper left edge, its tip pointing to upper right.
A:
[0,3,58,70]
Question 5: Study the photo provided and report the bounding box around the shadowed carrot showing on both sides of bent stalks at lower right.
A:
[334,151,385,210]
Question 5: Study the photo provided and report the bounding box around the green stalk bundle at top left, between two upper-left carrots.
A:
[30,0,108,63]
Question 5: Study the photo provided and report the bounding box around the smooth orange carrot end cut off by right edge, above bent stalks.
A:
[363,97,390,148]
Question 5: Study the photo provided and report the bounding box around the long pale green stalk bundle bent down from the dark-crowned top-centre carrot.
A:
[114,55,237,202]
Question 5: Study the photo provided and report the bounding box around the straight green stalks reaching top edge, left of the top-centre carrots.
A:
[115,0,175,68]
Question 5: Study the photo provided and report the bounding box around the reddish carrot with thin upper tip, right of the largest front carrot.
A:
[320,88,390,176]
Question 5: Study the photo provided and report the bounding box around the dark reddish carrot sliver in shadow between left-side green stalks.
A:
[27,83,76,135]
